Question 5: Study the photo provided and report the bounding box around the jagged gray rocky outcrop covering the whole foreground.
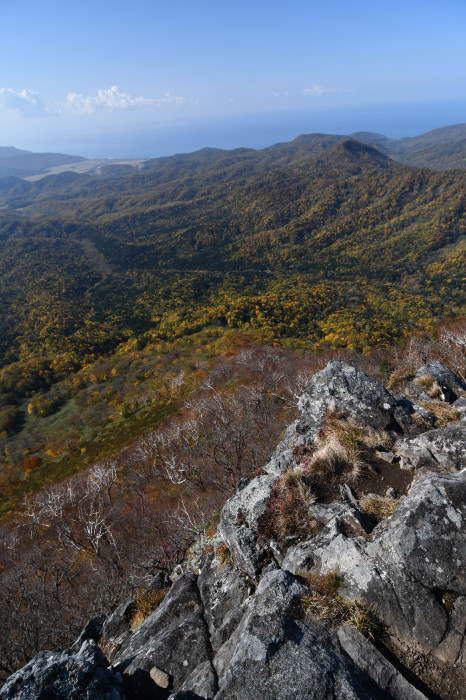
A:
[0,362,466,700]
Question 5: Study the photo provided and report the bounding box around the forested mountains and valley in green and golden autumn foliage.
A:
[0,134,465,516]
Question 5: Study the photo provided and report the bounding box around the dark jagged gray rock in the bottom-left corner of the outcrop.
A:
[0,639,125,700]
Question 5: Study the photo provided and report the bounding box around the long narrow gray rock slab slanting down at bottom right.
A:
[337,625,426,700]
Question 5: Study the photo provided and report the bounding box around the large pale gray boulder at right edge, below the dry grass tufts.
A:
[282,472,466,652]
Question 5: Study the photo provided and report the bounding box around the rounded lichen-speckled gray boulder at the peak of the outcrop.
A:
[298,360,396,438]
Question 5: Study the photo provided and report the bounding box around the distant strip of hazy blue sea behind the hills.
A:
[23,101,466,158]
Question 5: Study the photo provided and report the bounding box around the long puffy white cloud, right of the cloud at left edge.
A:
[65,85,186,114]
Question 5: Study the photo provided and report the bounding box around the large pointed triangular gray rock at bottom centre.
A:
[214,570,388,700]
